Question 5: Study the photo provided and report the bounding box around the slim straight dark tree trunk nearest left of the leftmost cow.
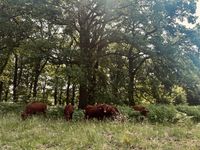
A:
[13,54,18,102]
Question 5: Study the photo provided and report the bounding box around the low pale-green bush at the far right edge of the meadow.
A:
[176,105,200,122]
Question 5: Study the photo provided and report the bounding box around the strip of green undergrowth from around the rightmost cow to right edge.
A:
[118,105,200,124]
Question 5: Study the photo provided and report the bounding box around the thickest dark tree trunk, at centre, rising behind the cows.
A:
[75,0,109,108]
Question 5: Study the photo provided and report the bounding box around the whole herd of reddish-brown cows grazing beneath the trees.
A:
[21,102,149,121]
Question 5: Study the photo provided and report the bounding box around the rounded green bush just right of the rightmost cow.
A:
[148,105,178,123]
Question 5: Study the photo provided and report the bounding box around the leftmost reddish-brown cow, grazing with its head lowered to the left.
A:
[21,102,47,120]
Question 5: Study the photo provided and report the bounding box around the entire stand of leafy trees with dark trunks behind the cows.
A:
[0,0,200,108]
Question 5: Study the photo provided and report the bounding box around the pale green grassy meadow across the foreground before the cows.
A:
[0,104,200,150]
